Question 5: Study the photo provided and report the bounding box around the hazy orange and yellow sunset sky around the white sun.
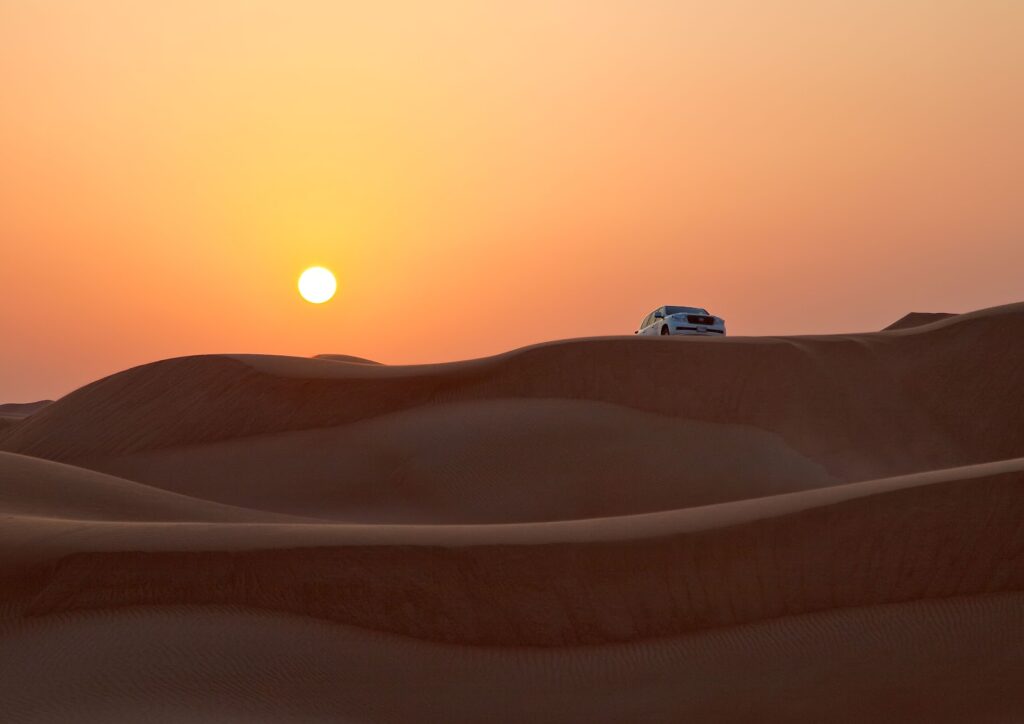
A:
[0,0,1024,401]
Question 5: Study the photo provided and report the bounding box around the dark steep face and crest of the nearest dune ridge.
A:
[8,461,1024,646]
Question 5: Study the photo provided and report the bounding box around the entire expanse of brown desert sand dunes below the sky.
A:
[0,304,1024,722]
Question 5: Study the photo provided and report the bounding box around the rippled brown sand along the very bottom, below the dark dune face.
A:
[0,594,1024,724]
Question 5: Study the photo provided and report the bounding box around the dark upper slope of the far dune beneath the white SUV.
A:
[6,304,1024,487]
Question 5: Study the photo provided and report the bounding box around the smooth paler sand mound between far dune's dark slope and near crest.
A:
[87,399,838,523]
